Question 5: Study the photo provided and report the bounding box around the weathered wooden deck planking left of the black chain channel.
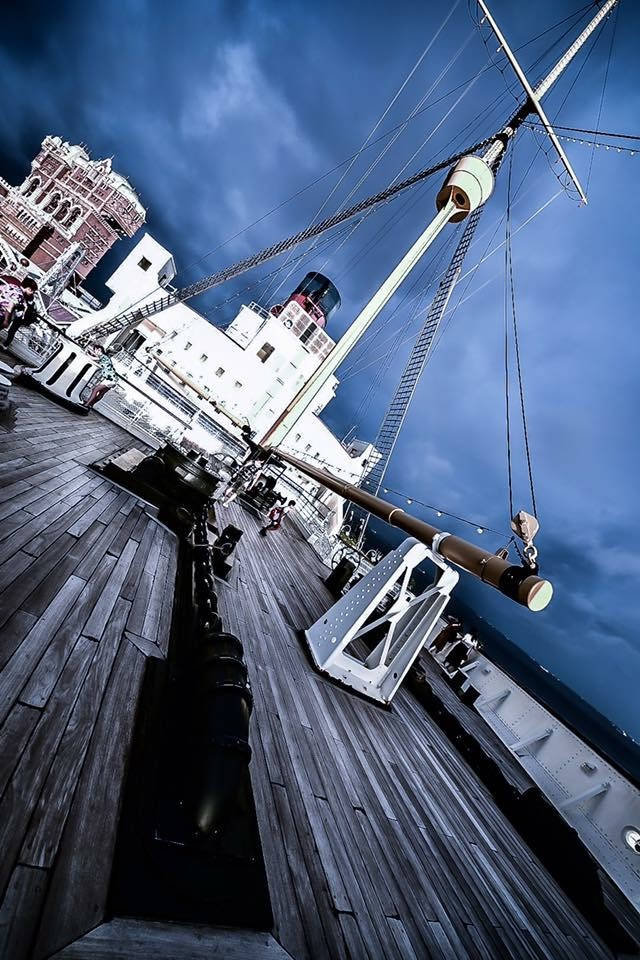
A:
[0,387,177,960]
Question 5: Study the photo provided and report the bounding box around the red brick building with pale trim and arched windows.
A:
[0,137,146,280]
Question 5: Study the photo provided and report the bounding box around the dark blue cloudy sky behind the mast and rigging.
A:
[0,0,640,739]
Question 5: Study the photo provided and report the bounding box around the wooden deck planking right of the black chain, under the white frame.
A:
[219,505,612,960]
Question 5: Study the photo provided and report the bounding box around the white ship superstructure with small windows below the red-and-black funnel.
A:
[67,234,374,533]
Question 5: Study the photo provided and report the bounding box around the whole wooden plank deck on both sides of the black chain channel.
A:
[0,378,612,960]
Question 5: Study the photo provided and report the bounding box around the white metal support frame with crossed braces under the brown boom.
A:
[305,534,459,703]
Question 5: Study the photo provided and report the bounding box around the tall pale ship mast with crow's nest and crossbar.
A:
[261,0,618,447]
